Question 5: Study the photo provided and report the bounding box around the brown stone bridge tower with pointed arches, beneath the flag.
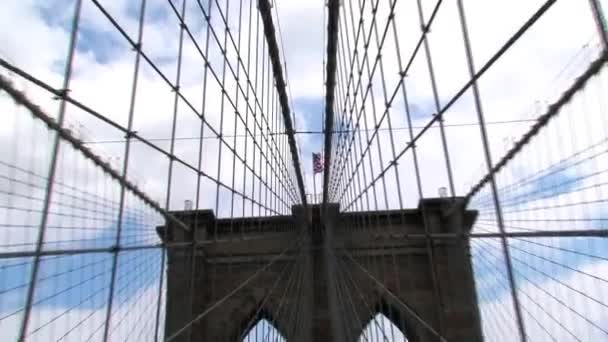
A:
[158,198,482,342]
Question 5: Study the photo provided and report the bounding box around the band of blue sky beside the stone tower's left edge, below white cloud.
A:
[0,208,161,312]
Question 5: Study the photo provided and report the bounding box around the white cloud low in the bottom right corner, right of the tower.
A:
[480,262,608,341]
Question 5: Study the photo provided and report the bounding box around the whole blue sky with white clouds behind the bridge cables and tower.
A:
[0,0,608,340]
